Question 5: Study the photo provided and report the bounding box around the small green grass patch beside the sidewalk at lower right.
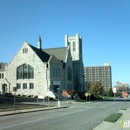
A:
[104,113,122,123]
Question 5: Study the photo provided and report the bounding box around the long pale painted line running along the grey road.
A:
[0,110,92,130]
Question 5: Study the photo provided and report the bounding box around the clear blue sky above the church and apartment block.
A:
[0,0,130,86]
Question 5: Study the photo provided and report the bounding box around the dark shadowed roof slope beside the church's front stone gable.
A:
[28,44,51,62]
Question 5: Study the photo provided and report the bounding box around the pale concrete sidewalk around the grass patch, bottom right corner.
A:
[93,109,130,130]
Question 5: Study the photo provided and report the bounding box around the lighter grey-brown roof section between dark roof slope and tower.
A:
[43,47,67,61]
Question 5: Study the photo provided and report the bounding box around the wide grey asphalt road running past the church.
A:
[0,102,130,130]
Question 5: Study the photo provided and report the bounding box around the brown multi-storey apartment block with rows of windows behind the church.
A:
[84,63,112,92]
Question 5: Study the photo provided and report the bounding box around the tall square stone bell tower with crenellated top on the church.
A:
[65,34,84,91]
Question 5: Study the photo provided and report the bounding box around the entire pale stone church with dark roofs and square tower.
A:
[0,34,84,97]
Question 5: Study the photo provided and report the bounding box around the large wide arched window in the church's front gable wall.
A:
[17,64,34,79]
